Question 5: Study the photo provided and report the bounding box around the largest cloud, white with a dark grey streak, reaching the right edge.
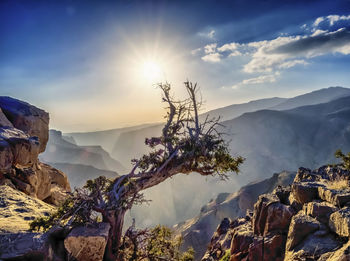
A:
[243,28,350,73]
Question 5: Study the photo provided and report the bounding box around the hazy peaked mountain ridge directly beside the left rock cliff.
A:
[40,130,125,172]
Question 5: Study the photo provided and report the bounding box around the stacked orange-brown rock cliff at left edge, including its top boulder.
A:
[0,97,70,205]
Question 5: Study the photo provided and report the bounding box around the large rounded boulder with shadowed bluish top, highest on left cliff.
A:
[0,97,49,152]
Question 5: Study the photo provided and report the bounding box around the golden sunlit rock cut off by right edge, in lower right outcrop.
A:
[329,207,350,237]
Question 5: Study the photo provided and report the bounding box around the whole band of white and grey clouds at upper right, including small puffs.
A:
[197,15,350,87]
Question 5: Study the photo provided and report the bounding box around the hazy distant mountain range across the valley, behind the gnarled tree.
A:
[47,87,350,226]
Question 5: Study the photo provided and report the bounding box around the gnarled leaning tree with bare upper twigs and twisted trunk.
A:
[31,81,244,261]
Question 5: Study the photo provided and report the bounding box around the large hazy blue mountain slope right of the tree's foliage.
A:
[222,96,350,184]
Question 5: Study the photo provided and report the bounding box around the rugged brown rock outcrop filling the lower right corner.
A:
[202,166,350,261]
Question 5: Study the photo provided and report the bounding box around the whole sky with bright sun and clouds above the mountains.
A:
[0,0,350,131]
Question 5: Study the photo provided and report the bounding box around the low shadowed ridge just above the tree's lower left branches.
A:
[49,162,118,188]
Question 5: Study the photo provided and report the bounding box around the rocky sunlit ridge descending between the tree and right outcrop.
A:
[174,171,296,260]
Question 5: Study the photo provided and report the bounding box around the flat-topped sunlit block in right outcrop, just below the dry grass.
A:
[303,202,337,224]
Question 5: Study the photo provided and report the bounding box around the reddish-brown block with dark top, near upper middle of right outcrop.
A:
[292,182,324,204]
